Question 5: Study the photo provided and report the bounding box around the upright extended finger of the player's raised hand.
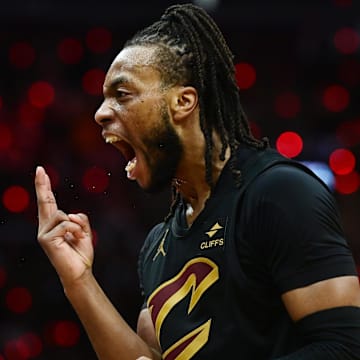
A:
[35,166,57,225]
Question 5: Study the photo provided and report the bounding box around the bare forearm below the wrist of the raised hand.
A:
[64,274,159,360]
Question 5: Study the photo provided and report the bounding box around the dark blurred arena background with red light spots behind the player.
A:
[0,0,360,360]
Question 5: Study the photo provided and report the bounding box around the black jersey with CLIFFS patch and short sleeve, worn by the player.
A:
[139,149,356,360]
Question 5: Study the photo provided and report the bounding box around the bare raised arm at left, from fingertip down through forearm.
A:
[35,167,160,360]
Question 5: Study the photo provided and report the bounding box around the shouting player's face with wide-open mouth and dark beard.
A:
[95,46,183,191]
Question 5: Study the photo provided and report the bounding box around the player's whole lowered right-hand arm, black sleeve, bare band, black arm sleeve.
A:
[246,167,360,360]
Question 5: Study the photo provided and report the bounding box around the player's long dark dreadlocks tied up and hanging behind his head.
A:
[125,4,268,221]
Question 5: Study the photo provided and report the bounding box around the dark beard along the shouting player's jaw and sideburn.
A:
[143,106,183,193]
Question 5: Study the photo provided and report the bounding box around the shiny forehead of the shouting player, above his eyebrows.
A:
[105,46,160,84]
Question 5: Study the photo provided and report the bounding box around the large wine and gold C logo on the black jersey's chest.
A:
[148,257,219,360]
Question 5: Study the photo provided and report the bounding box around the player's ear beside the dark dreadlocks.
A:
[170,86,198,122]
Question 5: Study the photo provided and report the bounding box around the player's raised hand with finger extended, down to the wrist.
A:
[35,166,94,286]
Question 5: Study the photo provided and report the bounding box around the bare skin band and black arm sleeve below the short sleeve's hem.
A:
[278,276,360,360]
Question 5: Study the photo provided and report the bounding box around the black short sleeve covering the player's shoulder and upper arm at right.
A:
[242,164,356,292]
